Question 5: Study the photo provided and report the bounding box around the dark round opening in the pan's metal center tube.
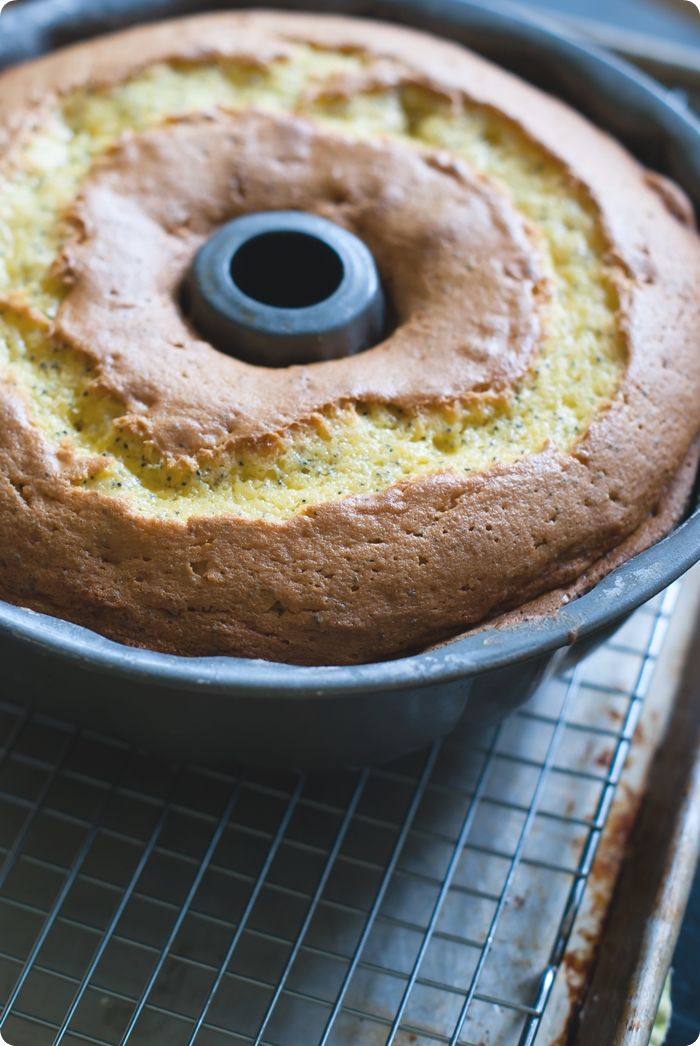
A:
[231,231,345,309]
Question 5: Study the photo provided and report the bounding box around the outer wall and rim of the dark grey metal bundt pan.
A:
[0,0,700,767]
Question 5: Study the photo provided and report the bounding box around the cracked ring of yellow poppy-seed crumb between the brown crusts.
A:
[0,45,627,521]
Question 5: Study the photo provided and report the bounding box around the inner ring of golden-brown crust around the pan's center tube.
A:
[58,111,546,458]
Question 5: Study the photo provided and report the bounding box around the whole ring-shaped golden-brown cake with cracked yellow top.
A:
[0,12,700,664]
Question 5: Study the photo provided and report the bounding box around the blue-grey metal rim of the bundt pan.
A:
[0,0,700,698]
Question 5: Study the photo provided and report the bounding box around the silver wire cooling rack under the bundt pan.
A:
[0,589,675,1046]
